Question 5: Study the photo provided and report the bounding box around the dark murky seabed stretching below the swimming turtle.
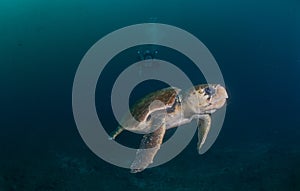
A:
[0,140,300,191]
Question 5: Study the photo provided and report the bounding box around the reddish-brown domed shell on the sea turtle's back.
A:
[130,87,181,121]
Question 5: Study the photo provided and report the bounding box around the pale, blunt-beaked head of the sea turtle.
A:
[183,84,228,114]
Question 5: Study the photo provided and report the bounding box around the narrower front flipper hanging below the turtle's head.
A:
[197,114,211,154]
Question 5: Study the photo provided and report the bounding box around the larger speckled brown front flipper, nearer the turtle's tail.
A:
[130,123,166,173]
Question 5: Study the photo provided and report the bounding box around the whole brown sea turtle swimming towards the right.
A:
[111,84,228,173]
